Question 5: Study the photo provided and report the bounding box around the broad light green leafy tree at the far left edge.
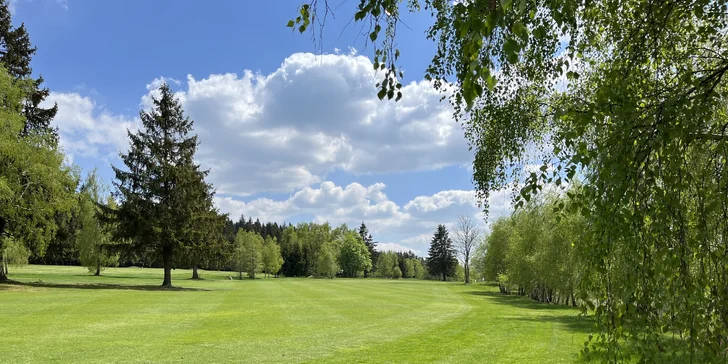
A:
[0,68,77,281]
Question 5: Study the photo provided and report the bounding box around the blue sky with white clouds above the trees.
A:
[11,0,510,255]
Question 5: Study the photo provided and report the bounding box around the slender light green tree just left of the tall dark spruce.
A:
[76,169,119,276]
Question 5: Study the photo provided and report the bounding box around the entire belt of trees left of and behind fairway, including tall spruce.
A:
[0,0,467,286]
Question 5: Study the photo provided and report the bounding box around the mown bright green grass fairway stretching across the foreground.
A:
[0,266,591,363]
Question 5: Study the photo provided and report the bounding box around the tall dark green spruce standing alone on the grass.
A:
[105,84,214,287]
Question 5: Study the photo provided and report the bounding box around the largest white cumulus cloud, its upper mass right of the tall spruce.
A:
[142,53,472,196]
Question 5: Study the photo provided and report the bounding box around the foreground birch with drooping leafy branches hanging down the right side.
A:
[288,0,728,362]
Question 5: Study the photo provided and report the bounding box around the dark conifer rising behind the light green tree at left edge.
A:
[0,0,58,147]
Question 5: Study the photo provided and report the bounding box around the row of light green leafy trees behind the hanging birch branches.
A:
[475,195,587,306]
